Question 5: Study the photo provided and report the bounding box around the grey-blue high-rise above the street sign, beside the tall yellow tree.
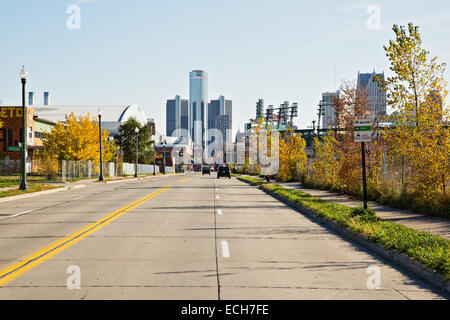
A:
[356,70,386,118]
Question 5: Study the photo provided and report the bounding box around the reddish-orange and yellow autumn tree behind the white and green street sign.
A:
[310,83,383,193]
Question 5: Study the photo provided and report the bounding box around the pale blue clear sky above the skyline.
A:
[0,0,450,133]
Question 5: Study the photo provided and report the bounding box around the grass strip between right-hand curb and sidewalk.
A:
[239,177,450,279]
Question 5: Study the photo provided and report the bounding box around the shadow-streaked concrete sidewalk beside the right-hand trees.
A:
[241,176,450,239]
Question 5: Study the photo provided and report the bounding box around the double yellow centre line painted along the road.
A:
[0,182,178,287]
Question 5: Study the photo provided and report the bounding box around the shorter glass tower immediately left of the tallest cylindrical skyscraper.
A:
[166,95,189,136]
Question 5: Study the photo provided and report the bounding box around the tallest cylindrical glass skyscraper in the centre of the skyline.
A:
[189,70,208,146]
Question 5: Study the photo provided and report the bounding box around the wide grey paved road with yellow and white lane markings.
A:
[0,173,443,299]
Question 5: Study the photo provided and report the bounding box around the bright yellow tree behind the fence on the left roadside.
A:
[42,112,116,162]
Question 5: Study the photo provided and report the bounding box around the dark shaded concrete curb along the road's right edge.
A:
[238,178,450,298]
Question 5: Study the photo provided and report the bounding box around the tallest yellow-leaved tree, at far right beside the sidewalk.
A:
[380,23,450,208]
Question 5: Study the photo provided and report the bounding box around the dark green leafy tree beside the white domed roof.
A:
[117,118,155,164]
